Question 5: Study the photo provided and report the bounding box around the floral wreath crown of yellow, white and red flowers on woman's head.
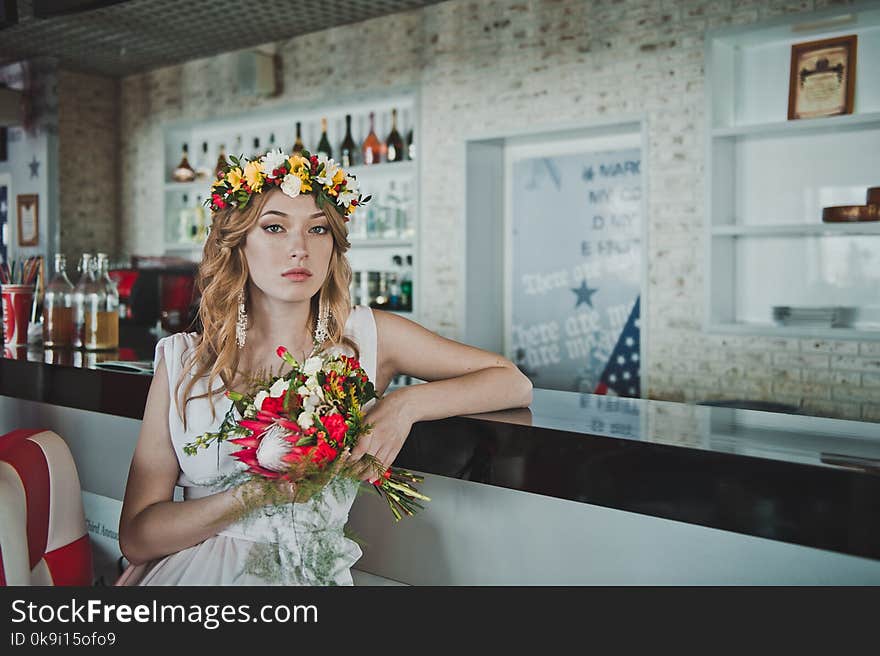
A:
[205,148,371,221]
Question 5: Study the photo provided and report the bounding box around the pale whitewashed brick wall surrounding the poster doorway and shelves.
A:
[121,0,880,421]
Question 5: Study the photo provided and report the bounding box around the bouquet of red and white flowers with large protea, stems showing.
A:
[184,346,430,520]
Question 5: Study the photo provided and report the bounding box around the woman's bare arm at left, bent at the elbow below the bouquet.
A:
[119,360,251,565]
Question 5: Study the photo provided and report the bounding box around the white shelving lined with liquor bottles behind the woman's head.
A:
[162,90,420,319]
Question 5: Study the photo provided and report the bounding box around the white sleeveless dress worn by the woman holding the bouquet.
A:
[128,305,377,585]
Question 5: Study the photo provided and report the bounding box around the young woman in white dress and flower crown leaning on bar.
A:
[119,151,532,585]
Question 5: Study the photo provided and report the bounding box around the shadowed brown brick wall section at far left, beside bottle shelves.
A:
[57,71,120,270]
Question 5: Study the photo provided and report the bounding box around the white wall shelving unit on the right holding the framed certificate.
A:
[705,2,880,340]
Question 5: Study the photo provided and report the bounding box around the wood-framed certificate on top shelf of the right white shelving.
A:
[788,34,857,120]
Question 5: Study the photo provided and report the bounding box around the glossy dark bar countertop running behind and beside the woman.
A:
[0,336,880,560]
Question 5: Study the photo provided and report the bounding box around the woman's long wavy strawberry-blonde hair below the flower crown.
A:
[174,190,360,429]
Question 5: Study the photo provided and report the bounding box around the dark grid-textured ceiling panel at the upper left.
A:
[0,0,438,77]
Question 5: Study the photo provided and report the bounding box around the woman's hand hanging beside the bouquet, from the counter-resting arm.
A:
[350,390,413,482]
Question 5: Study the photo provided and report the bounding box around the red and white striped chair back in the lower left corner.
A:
[0,430,93,586]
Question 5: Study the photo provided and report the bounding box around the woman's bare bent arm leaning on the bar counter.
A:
[373,310,532,422]
